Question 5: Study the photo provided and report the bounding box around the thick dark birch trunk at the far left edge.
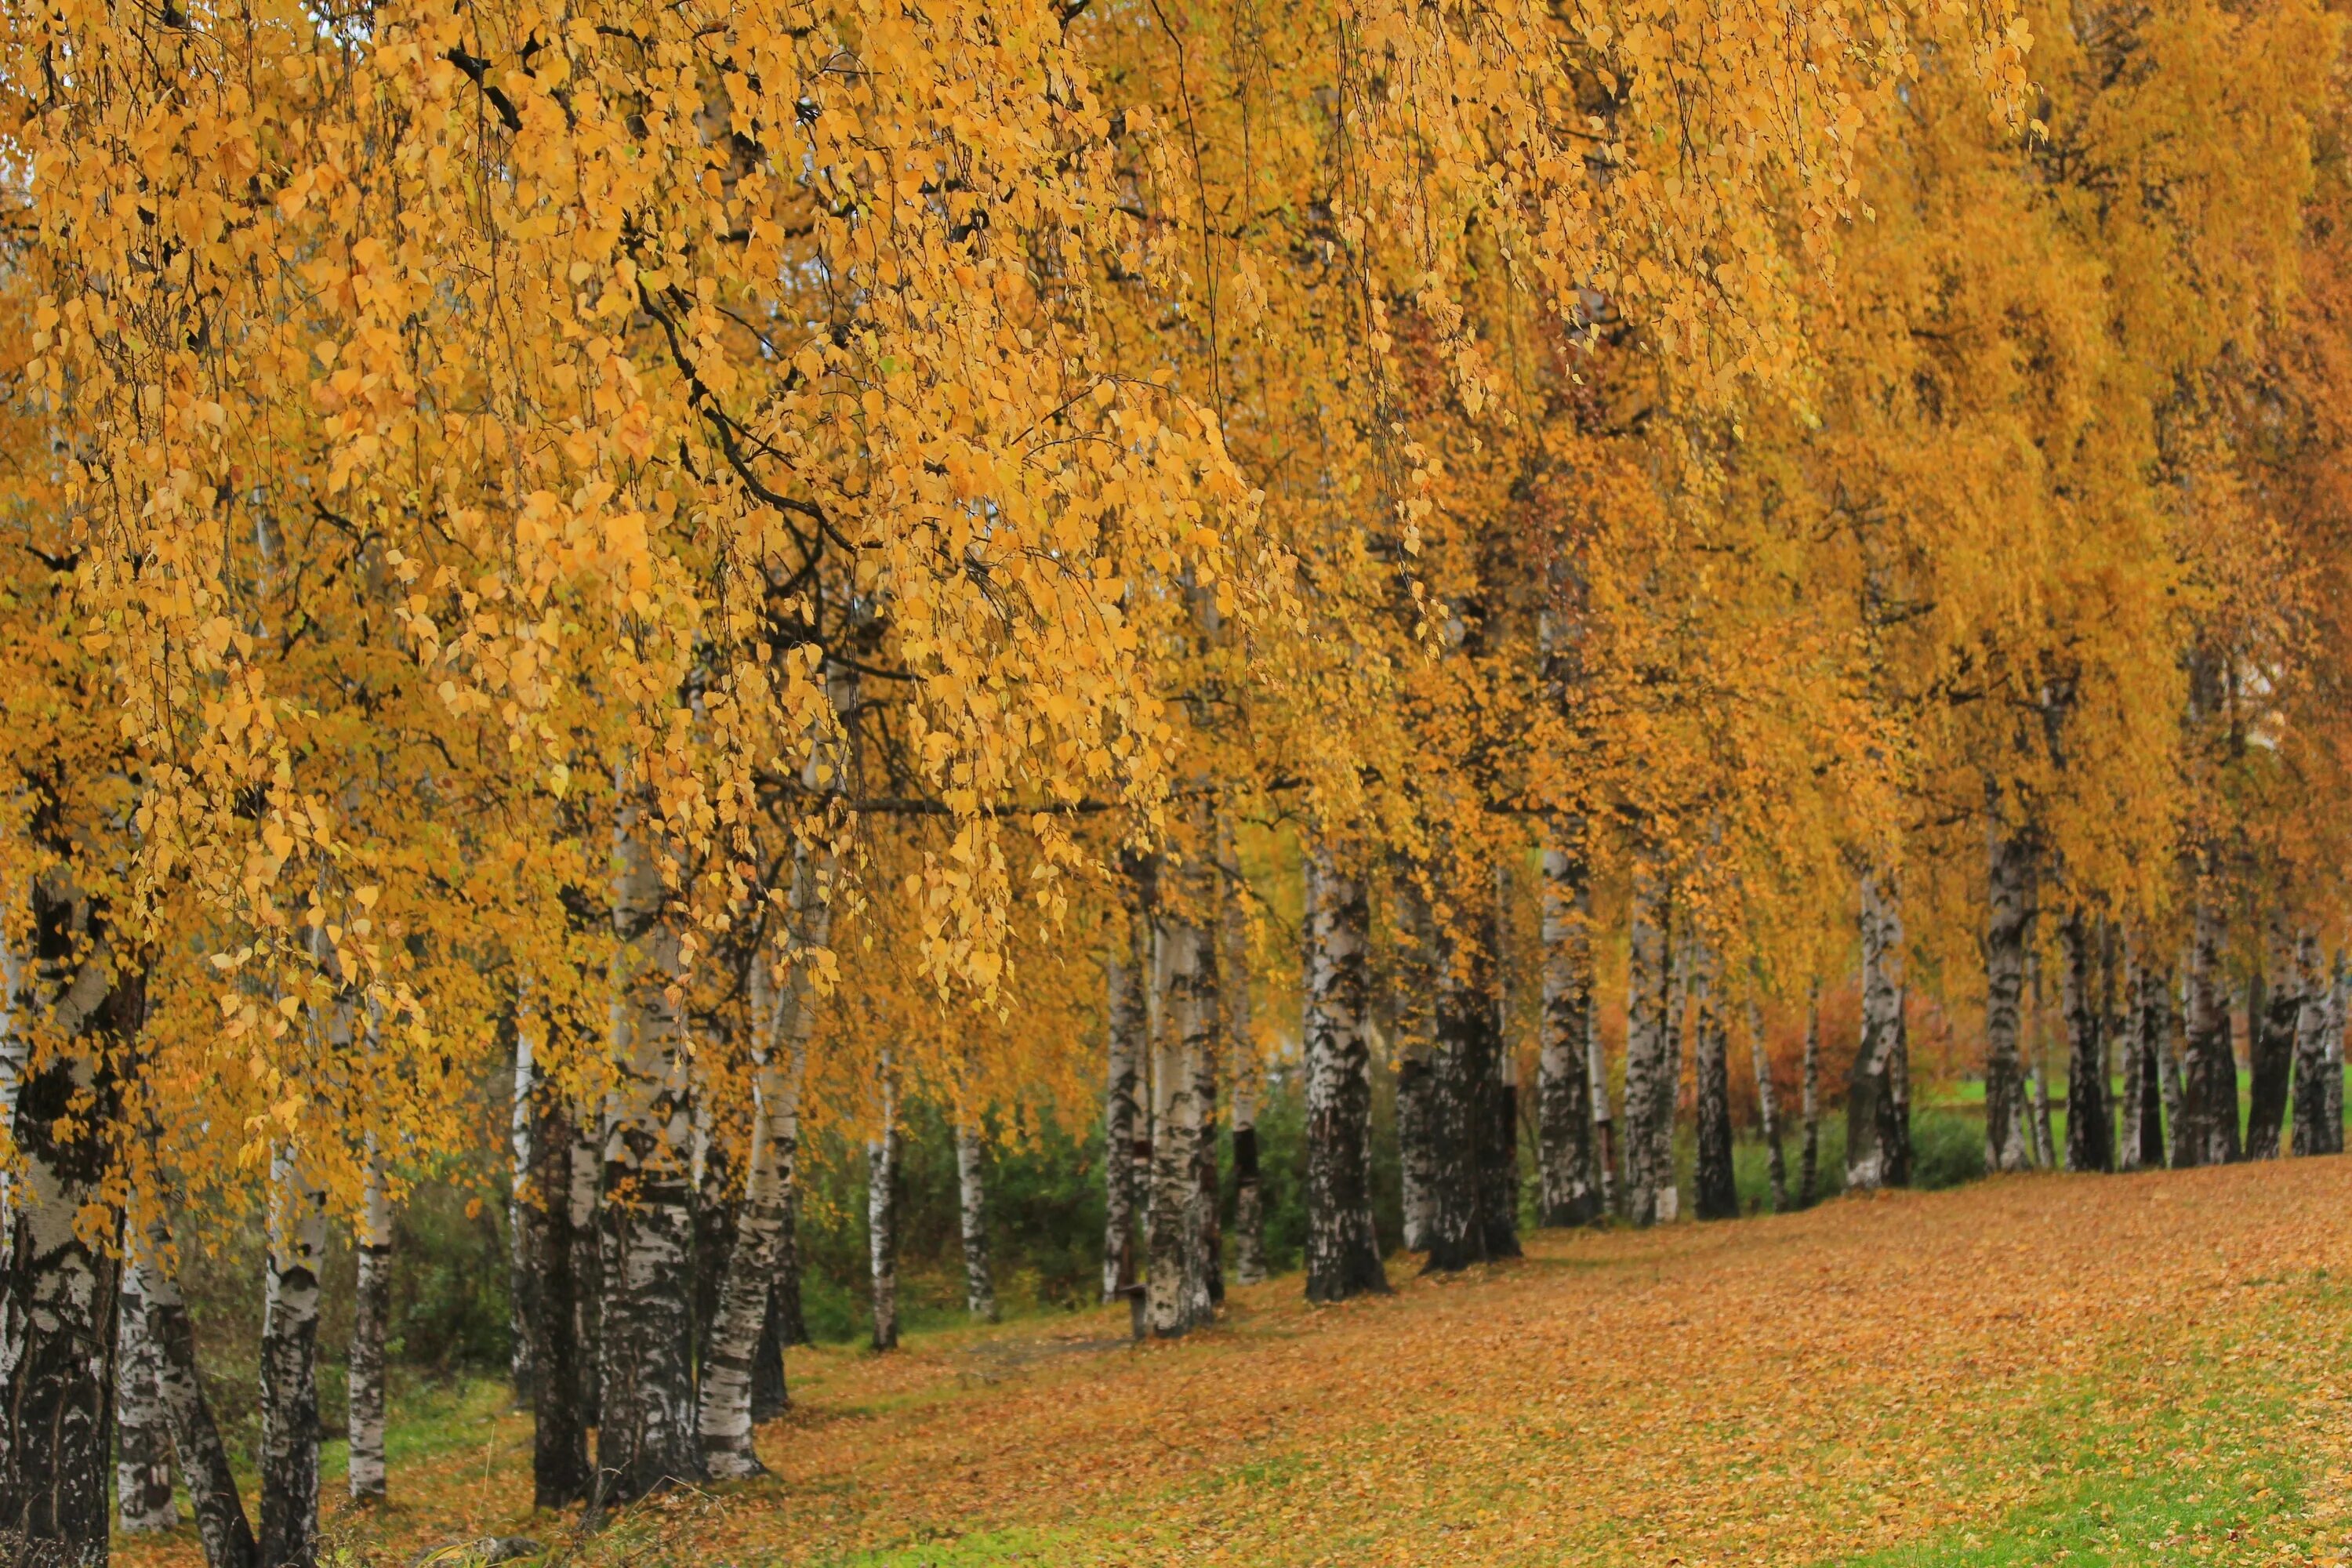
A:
[0,869,146,1563]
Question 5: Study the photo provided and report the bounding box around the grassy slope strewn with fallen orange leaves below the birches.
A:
[120,1159,2352,1568]
